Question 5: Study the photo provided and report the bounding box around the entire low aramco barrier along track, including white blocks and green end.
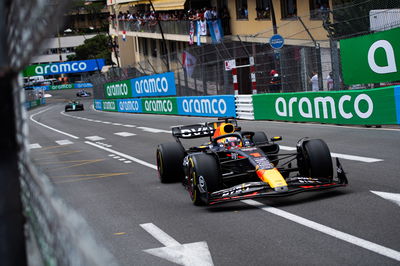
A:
[94,86,400,125]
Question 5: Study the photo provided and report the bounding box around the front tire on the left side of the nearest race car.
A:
[187,153,222,206]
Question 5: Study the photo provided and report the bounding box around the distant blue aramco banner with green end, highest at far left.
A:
[23,59,105,77]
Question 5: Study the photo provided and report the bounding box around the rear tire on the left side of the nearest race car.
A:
[156,142,185,183]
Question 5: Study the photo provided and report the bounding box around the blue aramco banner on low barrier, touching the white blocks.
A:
[177,95,236,117]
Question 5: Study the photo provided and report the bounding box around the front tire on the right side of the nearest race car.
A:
[297,139,333,179]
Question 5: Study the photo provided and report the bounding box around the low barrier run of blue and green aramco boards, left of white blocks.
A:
[94,95,236,117]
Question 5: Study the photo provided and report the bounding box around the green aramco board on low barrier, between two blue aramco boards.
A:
[142,97,178,115]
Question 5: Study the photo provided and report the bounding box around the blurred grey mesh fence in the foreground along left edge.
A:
[5,0,116,265]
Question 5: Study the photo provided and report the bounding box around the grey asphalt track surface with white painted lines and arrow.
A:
[29,92,400,265]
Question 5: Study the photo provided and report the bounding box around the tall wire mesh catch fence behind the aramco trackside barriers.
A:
[92,0,400,98]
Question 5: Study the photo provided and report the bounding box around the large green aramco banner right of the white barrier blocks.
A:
[253,86,400,125]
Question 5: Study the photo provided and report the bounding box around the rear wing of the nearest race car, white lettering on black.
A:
[172,117,240,139]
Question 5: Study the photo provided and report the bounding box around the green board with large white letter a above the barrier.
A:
[340,28,400,85]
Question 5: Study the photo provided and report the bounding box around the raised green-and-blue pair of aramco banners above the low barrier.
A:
[104,72,176,99]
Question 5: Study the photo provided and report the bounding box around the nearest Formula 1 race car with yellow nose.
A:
[156,118,348,205]
